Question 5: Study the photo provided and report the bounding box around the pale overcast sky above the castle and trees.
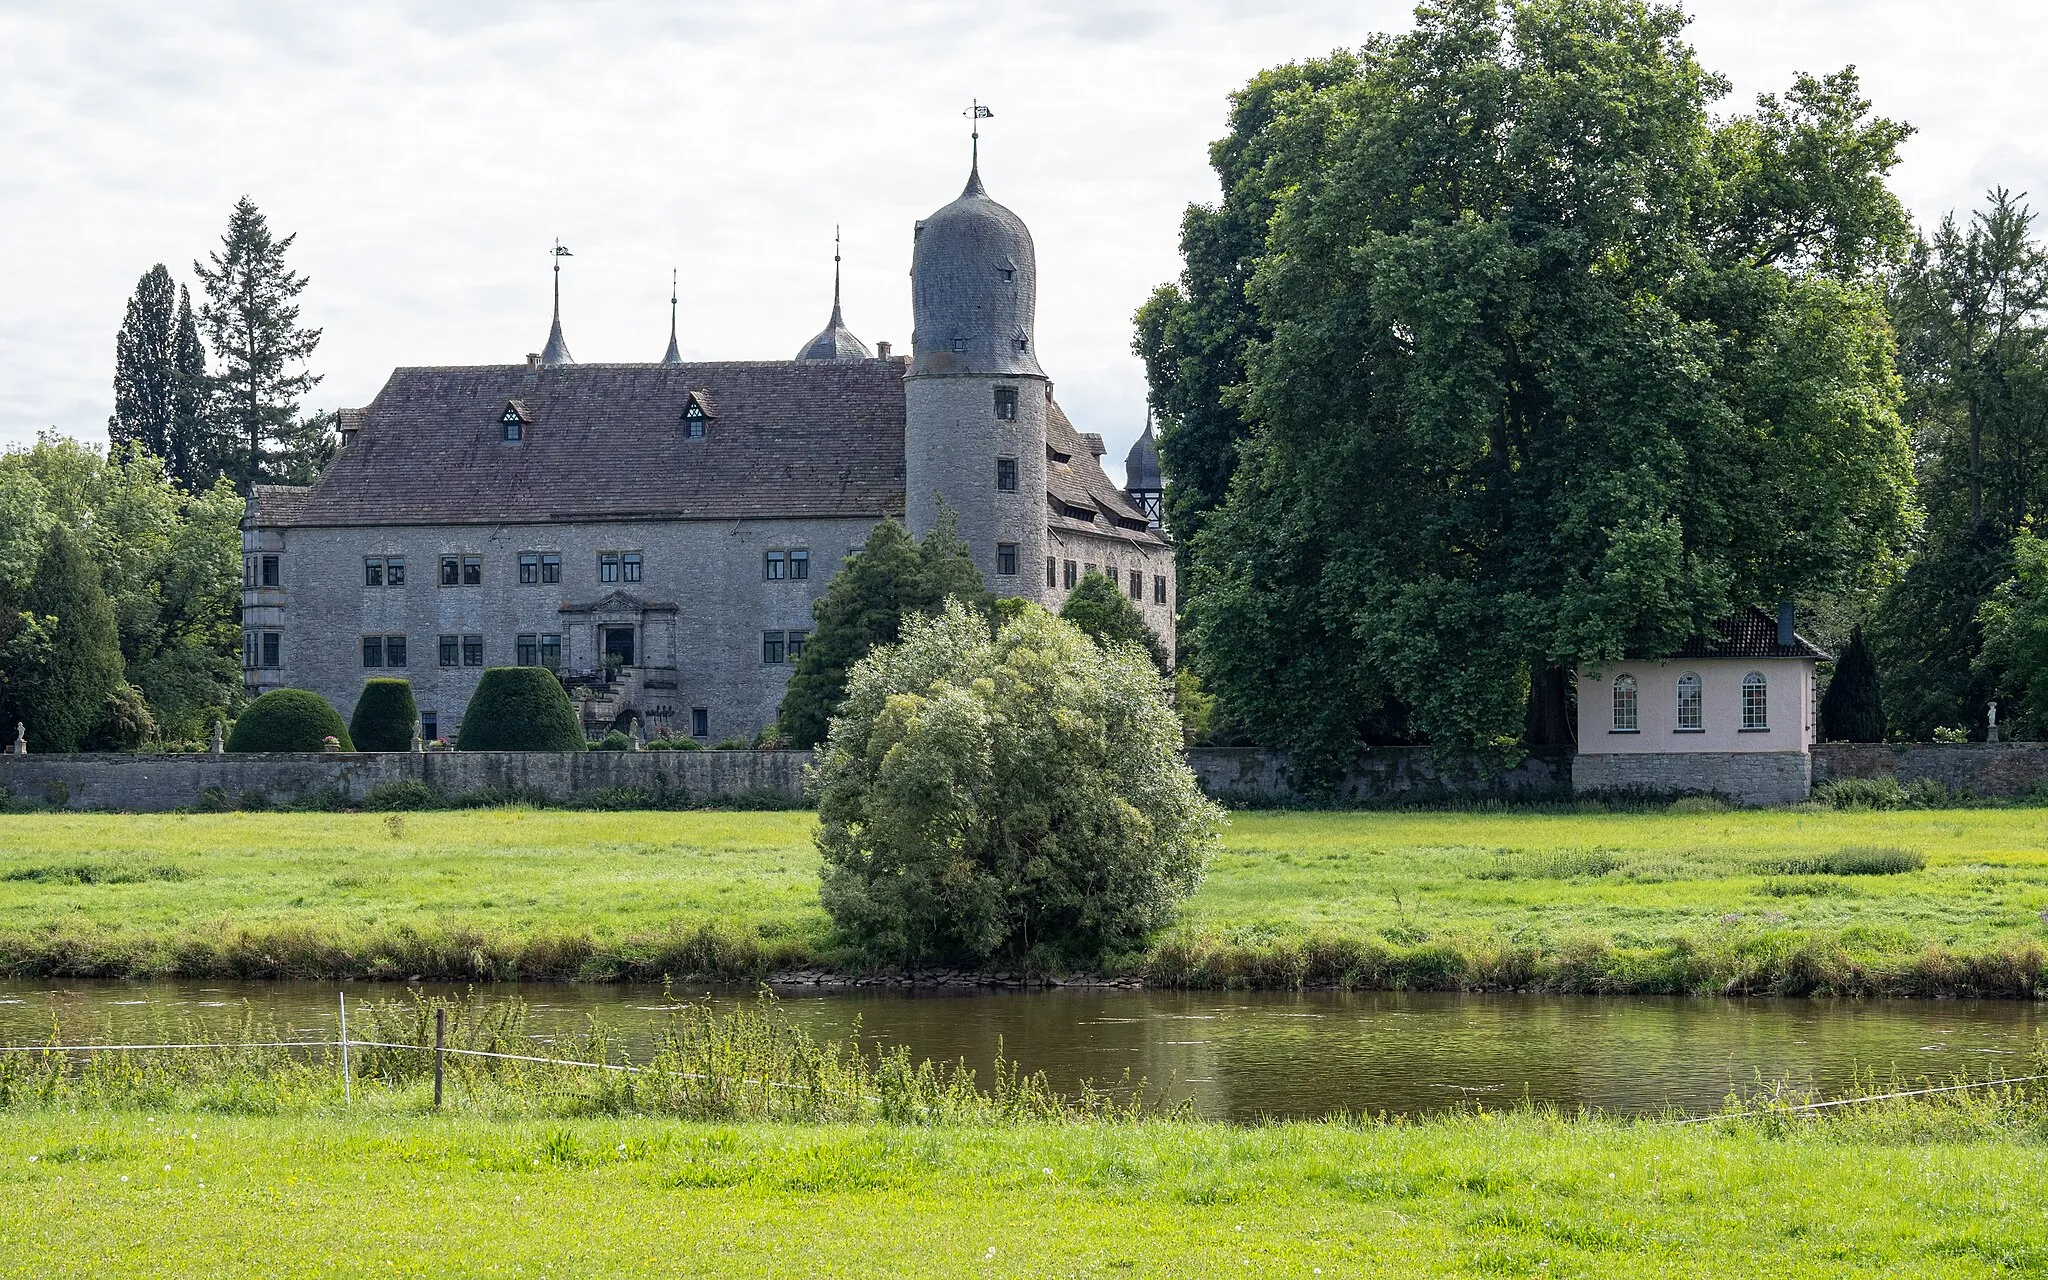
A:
[0,0,2048,483]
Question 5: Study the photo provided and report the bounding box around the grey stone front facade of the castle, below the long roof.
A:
[242,518,874,745]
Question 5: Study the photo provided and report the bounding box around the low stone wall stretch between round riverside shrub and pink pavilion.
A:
[1188,748,1571,805]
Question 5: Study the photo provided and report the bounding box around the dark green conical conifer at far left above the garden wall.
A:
[8,524,123,752]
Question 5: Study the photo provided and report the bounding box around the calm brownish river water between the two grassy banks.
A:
[0,981,2044,1120]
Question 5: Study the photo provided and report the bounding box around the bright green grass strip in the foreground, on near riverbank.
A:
[0,1102,2048,1280]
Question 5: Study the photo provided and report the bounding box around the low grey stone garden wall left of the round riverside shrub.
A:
[0,752,811,813]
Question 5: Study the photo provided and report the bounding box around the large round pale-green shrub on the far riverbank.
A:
[817,602,1223,967]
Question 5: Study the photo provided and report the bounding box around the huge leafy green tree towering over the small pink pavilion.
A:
[1141,0,1911,778]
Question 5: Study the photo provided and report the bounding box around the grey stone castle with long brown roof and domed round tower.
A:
[242,164,1174,741]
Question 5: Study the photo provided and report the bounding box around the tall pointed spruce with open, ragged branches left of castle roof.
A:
[193,197,319,494]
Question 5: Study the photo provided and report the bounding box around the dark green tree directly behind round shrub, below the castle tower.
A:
[776,508,989,748]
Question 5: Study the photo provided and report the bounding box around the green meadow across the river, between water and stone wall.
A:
[0,809,2048,995]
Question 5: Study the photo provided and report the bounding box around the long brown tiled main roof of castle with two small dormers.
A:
[252,360,903,526]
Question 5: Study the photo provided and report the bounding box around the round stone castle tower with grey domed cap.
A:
[903,166,1049,600]
